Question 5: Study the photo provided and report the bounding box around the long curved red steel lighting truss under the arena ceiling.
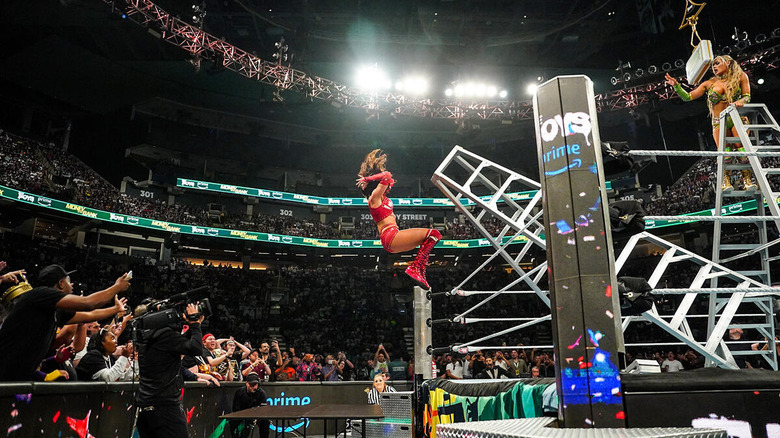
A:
[103,0,780,120]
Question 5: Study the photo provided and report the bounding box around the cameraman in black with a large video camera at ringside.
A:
[135,303,205,438]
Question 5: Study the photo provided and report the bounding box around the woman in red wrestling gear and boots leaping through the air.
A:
[356,149,441,289]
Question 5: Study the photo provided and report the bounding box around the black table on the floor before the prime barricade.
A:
[220,404,385,437]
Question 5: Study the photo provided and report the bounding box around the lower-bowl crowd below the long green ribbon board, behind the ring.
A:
[0,233,765,381]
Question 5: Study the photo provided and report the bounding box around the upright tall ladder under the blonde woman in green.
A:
[707,103,780,370]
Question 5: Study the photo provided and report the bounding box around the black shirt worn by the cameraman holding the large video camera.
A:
[135,323,203,407]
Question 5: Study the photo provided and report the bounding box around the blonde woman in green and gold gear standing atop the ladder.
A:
[666,55,757,191]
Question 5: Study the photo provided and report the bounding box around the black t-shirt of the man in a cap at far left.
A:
[0,287,66,381]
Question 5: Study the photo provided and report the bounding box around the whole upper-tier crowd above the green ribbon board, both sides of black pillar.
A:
[10,126,772,245]
